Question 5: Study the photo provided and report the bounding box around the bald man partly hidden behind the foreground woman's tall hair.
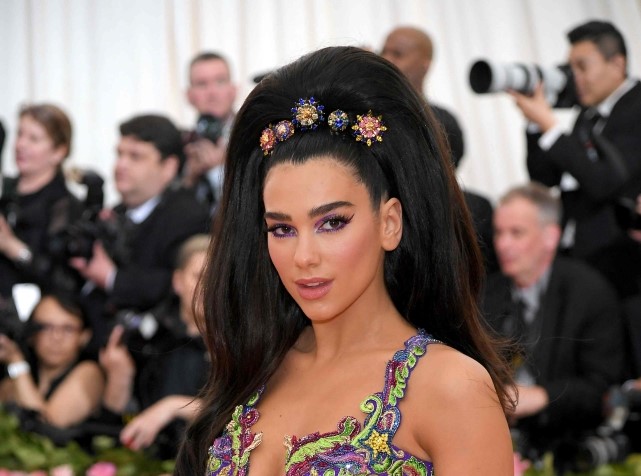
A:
[381,26,465,166]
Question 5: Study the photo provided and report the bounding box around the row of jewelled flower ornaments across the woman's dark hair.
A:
[259,96,387,156]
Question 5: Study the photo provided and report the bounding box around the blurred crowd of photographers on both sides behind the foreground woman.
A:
[0,21,641,469]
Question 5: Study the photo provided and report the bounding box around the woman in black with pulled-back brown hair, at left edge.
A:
[0,104,84,300]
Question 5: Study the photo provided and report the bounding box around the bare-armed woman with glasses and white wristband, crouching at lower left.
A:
[0,294,104,428]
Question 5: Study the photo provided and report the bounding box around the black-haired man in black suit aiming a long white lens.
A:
[513,21,641,296]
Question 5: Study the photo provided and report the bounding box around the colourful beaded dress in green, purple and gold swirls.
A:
[206,330,438,476]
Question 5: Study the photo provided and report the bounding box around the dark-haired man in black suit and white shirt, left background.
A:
[71,115,209,343]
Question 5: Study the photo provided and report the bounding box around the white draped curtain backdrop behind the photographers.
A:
[0,0,641,204]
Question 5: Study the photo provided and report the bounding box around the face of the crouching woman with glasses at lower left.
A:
[32,297,90,368]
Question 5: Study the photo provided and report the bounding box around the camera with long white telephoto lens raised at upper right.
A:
[470,60,579,108]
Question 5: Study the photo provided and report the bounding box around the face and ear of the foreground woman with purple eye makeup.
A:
[263,157,400,322]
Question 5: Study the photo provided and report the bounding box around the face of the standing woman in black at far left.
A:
[16,115,65,176]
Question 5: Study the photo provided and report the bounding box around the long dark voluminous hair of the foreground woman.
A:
[176,43,511,475]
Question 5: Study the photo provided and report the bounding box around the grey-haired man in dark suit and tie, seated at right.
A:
[483,183,624,458]
